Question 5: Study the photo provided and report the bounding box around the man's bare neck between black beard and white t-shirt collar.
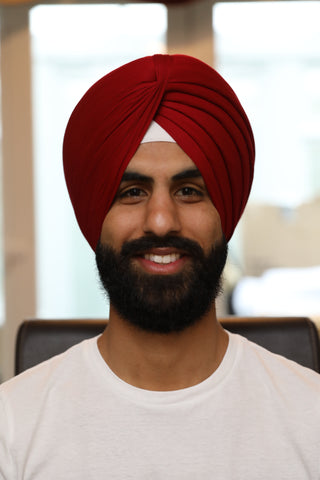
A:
[98,306,228,391]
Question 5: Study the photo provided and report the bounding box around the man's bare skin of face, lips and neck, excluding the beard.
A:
[98,142,228,391]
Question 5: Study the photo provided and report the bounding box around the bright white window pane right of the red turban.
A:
[214,2,320,207]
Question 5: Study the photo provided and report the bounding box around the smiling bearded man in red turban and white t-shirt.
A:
[0,55,320,480]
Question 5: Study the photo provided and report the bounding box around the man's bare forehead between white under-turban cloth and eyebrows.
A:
[126,142,197,177]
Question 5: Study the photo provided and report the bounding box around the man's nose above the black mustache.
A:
[144,192,181,237]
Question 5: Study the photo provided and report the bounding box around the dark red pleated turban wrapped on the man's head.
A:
[63,55,254,249]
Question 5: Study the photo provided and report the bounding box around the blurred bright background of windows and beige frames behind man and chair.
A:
[0,0,320,379]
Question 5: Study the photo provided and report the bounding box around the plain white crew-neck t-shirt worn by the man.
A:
[0,334,320,480]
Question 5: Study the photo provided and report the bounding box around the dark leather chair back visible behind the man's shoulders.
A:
[15,316,320,374]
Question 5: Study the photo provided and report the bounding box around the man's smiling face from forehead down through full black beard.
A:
[96,142,227,333]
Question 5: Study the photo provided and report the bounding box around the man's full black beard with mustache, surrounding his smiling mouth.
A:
[96,236,228,334]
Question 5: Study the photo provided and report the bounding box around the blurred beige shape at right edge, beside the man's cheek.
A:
[241,197,320,276]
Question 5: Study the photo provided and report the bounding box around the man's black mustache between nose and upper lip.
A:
[121,235,204,258]
